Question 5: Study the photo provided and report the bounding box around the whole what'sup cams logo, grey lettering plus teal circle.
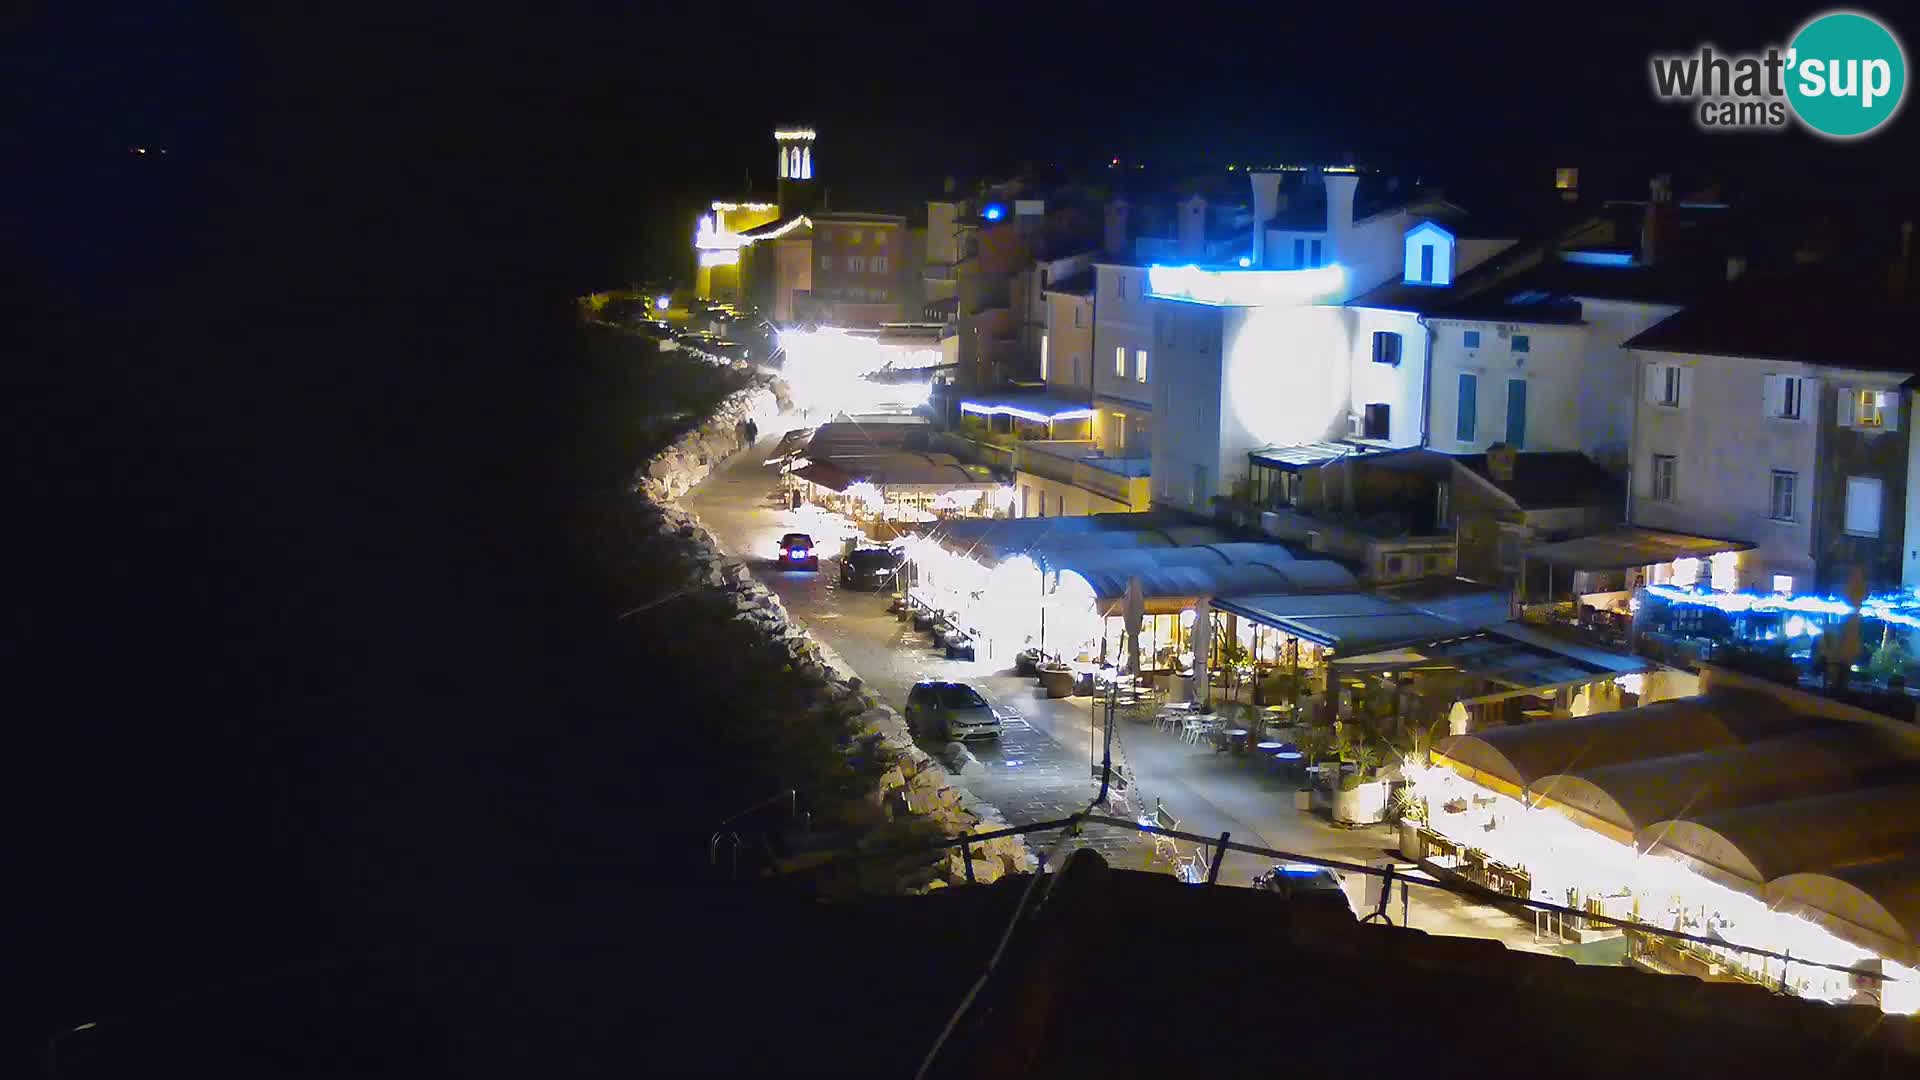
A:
[1647,12,1907,138]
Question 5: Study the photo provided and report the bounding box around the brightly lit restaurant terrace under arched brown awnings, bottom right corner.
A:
[1405,698,1920,1013]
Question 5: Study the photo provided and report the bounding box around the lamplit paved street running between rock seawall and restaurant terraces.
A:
[682,421,1551,951]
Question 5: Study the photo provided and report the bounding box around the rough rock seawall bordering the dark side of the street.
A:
[634,379,1037,892]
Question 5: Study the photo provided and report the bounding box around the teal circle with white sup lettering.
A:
[1788,12,1907,138]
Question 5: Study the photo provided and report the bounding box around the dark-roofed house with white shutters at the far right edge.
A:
[1626,267,1916,594]
